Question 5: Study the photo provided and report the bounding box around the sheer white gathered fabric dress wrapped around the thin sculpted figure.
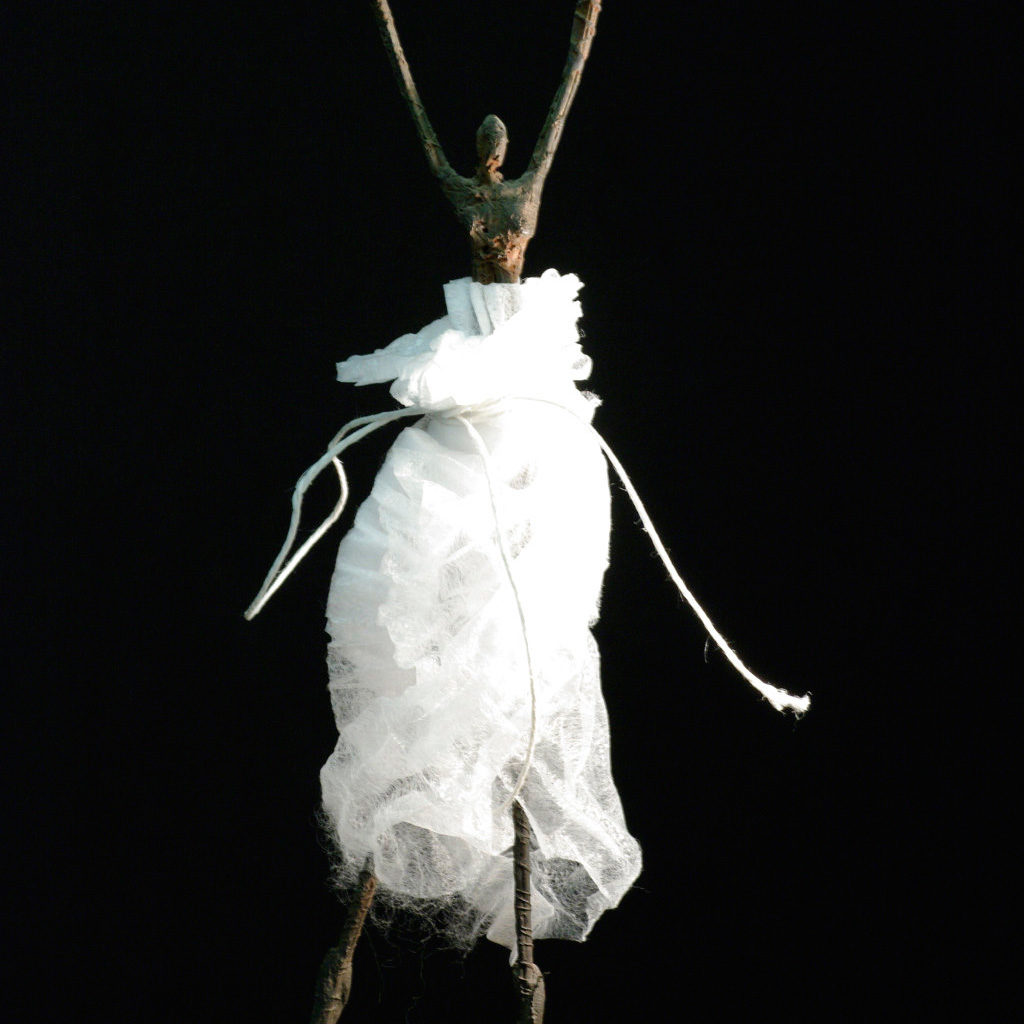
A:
[321,270,640,948]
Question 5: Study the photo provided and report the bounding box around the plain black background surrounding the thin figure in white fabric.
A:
[2,0,1020,1024]
